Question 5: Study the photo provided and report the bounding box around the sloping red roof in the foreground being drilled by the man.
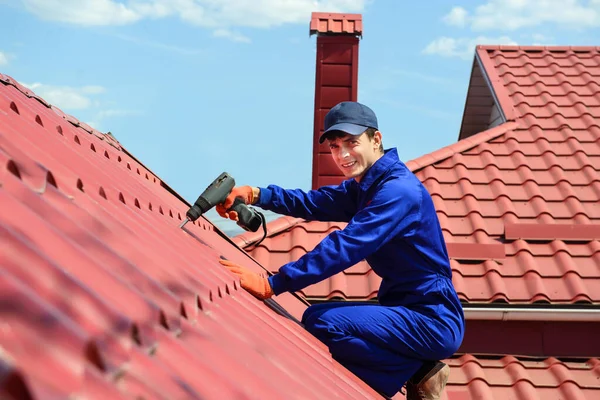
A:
[0,76,384,399]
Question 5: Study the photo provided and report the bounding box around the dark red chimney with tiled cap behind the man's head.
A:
[310,13,362,189]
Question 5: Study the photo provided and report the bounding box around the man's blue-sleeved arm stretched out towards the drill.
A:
[255,181,357,222]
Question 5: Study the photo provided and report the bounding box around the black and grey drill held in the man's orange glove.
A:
[179,172,264,232]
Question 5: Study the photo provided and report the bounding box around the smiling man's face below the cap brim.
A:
[329,132,382,182]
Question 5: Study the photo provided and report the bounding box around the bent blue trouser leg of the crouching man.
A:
[302,302,460,397]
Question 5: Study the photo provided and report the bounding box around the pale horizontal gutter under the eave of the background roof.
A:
[463,306,600,322]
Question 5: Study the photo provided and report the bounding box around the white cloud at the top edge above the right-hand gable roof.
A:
[444,0,600,31]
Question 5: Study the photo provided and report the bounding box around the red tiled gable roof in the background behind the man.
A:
[235,46,600,303]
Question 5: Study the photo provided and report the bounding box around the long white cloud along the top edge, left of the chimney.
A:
[21,0,370,29]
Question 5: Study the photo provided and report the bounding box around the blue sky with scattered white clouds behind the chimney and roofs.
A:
[0,0,600,233]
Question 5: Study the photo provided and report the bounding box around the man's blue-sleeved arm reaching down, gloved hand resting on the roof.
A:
[269,180,422,295]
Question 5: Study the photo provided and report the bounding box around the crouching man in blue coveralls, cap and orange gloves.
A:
[217,102,464,400]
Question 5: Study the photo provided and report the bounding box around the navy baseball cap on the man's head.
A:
[319,101,379,143]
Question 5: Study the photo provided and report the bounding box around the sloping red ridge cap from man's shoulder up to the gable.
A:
[406,121,519,173]
